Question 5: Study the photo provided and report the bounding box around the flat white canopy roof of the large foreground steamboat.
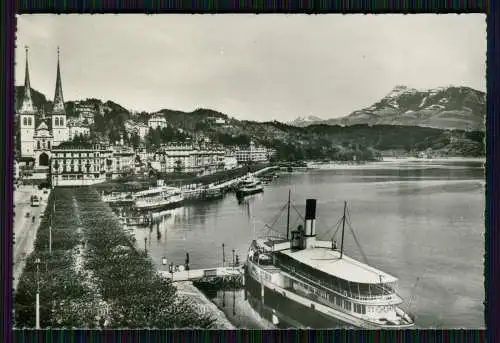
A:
[280,247,398,284]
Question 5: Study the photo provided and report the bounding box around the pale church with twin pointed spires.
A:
[16,47,69,168]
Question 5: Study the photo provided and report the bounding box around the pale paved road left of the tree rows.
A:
[13,185,50,289]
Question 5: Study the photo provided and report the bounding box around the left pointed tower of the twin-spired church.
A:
[18,46,36,157]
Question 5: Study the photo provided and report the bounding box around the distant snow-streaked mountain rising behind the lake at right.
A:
[290,86,486,131]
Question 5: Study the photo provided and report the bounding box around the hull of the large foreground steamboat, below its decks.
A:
[245,265,413,329]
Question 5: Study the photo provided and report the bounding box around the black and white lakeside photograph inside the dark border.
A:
[12,14,487,330]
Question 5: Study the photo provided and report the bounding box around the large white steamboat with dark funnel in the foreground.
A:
[245,195,414,329]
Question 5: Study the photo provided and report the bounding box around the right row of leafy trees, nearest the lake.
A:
[75,188,214,329]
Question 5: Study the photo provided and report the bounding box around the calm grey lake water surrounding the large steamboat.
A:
[125,160,485,328]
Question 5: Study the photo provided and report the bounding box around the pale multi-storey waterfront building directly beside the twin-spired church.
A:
[51,142,113,186]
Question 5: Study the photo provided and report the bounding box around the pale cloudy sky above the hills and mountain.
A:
[15,14,486,122]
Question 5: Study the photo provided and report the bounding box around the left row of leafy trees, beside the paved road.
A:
[14,188,99,328]
